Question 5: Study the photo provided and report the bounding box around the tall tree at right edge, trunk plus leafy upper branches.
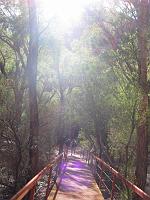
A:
[85,0,150,194]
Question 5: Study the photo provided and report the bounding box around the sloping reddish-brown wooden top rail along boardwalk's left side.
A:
[10,153,63,200]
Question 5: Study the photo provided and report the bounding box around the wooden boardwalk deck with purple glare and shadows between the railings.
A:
[48,155,104,200]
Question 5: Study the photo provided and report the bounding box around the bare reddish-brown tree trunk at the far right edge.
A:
[134,0,149,199]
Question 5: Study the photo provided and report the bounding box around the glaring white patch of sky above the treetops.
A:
[38,0,100,29]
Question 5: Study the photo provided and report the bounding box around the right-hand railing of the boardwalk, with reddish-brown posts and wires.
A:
[81,151,150,200]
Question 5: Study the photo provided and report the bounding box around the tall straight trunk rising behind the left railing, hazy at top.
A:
[27,0,39,178]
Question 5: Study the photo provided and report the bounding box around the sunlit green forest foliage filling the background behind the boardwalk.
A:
[0,1,150,199]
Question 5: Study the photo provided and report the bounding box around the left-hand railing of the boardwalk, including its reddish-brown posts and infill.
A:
[11,154,63,200]
